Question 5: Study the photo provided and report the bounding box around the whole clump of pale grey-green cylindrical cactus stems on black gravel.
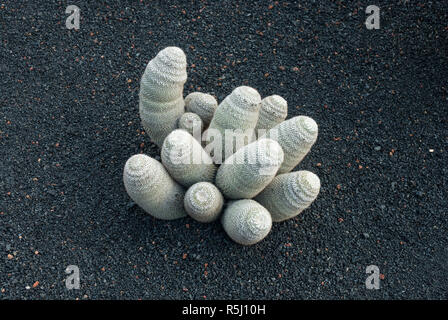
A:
[123,47,320,245]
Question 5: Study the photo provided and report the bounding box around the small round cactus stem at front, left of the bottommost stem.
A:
[184,182,224,222]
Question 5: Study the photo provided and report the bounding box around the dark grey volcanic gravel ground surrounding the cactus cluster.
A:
[0,0,448,300]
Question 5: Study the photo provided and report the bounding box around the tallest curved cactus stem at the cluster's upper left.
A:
[139,47,187,147]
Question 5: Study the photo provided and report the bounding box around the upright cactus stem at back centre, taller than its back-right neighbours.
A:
[206,86,261,163]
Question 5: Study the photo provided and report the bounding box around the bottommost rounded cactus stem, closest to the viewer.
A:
[221,199,272,245]
